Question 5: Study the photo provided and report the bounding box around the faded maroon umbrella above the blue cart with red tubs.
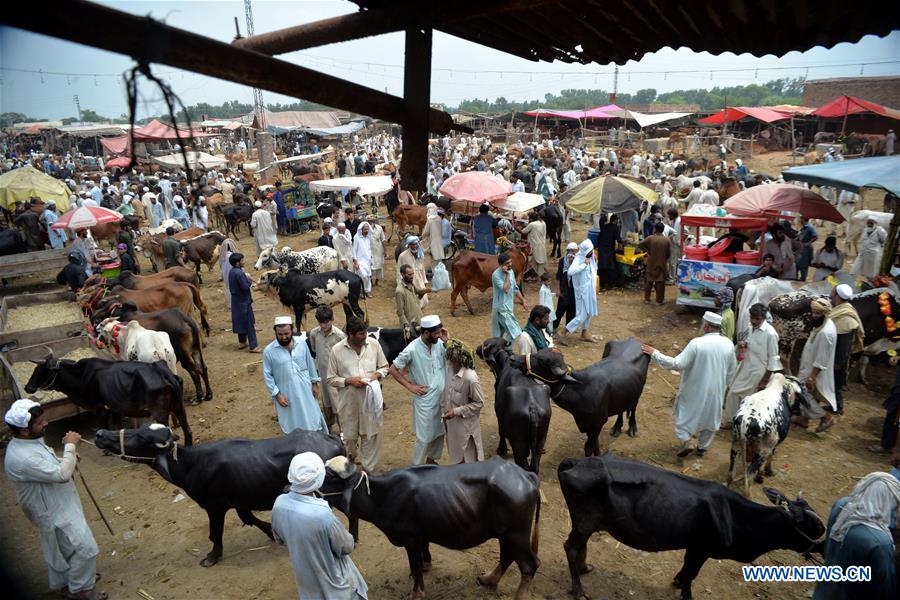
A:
[723,183,844,223]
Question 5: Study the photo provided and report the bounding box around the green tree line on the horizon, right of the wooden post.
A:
[451,79,803,112]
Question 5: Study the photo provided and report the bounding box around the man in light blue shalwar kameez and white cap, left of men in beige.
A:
[263,317,328,433]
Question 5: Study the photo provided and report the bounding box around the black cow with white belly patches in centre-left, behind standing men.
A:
[256,269,366,327]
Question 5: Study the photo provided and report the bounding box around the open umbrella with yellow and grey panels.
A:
[559,175,658,214]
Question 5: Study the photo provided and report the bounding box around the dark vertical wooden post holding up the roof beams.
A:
[400,28,432,191]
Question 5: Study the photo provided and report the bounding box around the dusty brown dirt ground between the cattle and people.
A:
[0,154,894,600]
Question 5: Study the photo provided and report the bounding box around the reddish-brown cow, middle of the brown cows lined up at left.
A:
[78,281,209,336]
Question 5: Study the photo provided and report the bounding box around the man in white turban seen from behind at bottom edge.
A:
[272,452,368,600]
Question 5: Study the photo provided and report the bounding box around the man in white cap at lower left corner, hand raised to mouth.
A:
[3,399,106,598]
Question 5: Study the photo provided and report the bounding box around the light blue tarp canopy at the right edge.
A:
[782,154,900,196]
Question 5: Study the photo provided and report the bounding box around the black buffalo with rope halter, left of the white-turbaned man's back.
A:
[95,423,345,567]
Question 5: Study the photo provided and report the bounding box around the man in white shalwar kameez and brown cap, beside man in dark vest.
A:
[791,298,837,433]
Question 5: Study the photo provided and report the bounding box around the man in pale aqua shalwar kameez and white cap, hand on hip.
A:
[390,315,448,465]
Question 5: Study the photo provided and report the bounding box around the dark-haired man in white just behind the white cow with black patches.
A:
[722,303,783,429]
